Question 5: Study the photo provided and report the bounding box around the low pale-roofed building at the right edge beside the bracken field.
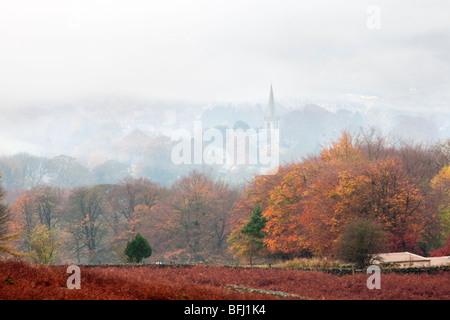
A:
[376,251,450,267]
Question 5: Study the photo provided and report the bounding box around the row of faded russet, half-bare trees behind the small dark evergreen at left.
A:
[3,171,239,263]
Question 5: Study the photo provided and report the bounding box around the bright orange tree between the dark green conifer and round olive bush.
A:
[264,132,364,257]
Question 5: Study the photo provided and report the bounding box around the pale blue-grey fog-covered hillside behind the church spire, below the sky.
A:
[0,91,450,189]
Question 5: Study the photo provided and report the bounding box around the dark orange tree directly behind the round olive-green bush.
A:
[331,159,424,251]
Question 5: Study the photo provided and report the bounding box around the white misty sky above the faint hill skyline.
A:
[0,0,450,110]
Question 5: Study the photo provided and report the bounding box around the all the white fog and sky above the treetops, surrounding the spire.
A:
[0,0,450,189]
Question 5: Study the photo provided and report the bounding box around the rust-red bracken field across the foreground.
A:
[0,261,450,300]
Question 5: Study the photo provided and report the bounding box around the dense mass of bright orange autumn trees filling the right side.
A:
[232,131,450,257]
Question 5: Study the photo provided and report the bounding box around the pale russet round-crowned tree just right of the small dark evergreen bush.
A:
[158,171,237,261]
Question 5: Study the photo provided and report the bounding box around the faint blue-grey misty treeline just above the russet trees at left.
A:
[0,134,255,193]
